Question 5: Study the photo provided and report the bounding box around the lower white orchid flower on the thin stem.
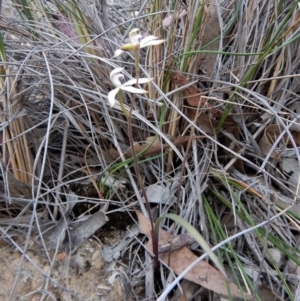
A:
[108,68,153,107]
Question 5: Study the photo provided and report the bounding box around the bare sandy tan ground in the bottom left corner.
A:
[0,239,130,301]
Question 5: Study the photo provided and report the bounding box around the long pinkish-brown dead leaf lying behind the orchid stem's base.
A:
[136,210,251,300]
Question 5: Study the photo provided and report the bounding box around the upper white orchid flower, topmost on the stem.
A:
[113,28,166,58]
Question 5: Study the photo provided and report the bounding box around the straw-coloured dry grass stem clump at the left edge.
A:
[0,65,36,194]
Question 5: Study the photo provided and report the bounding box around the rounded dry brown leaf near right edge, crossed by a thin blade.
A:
[260,124,288,160]
